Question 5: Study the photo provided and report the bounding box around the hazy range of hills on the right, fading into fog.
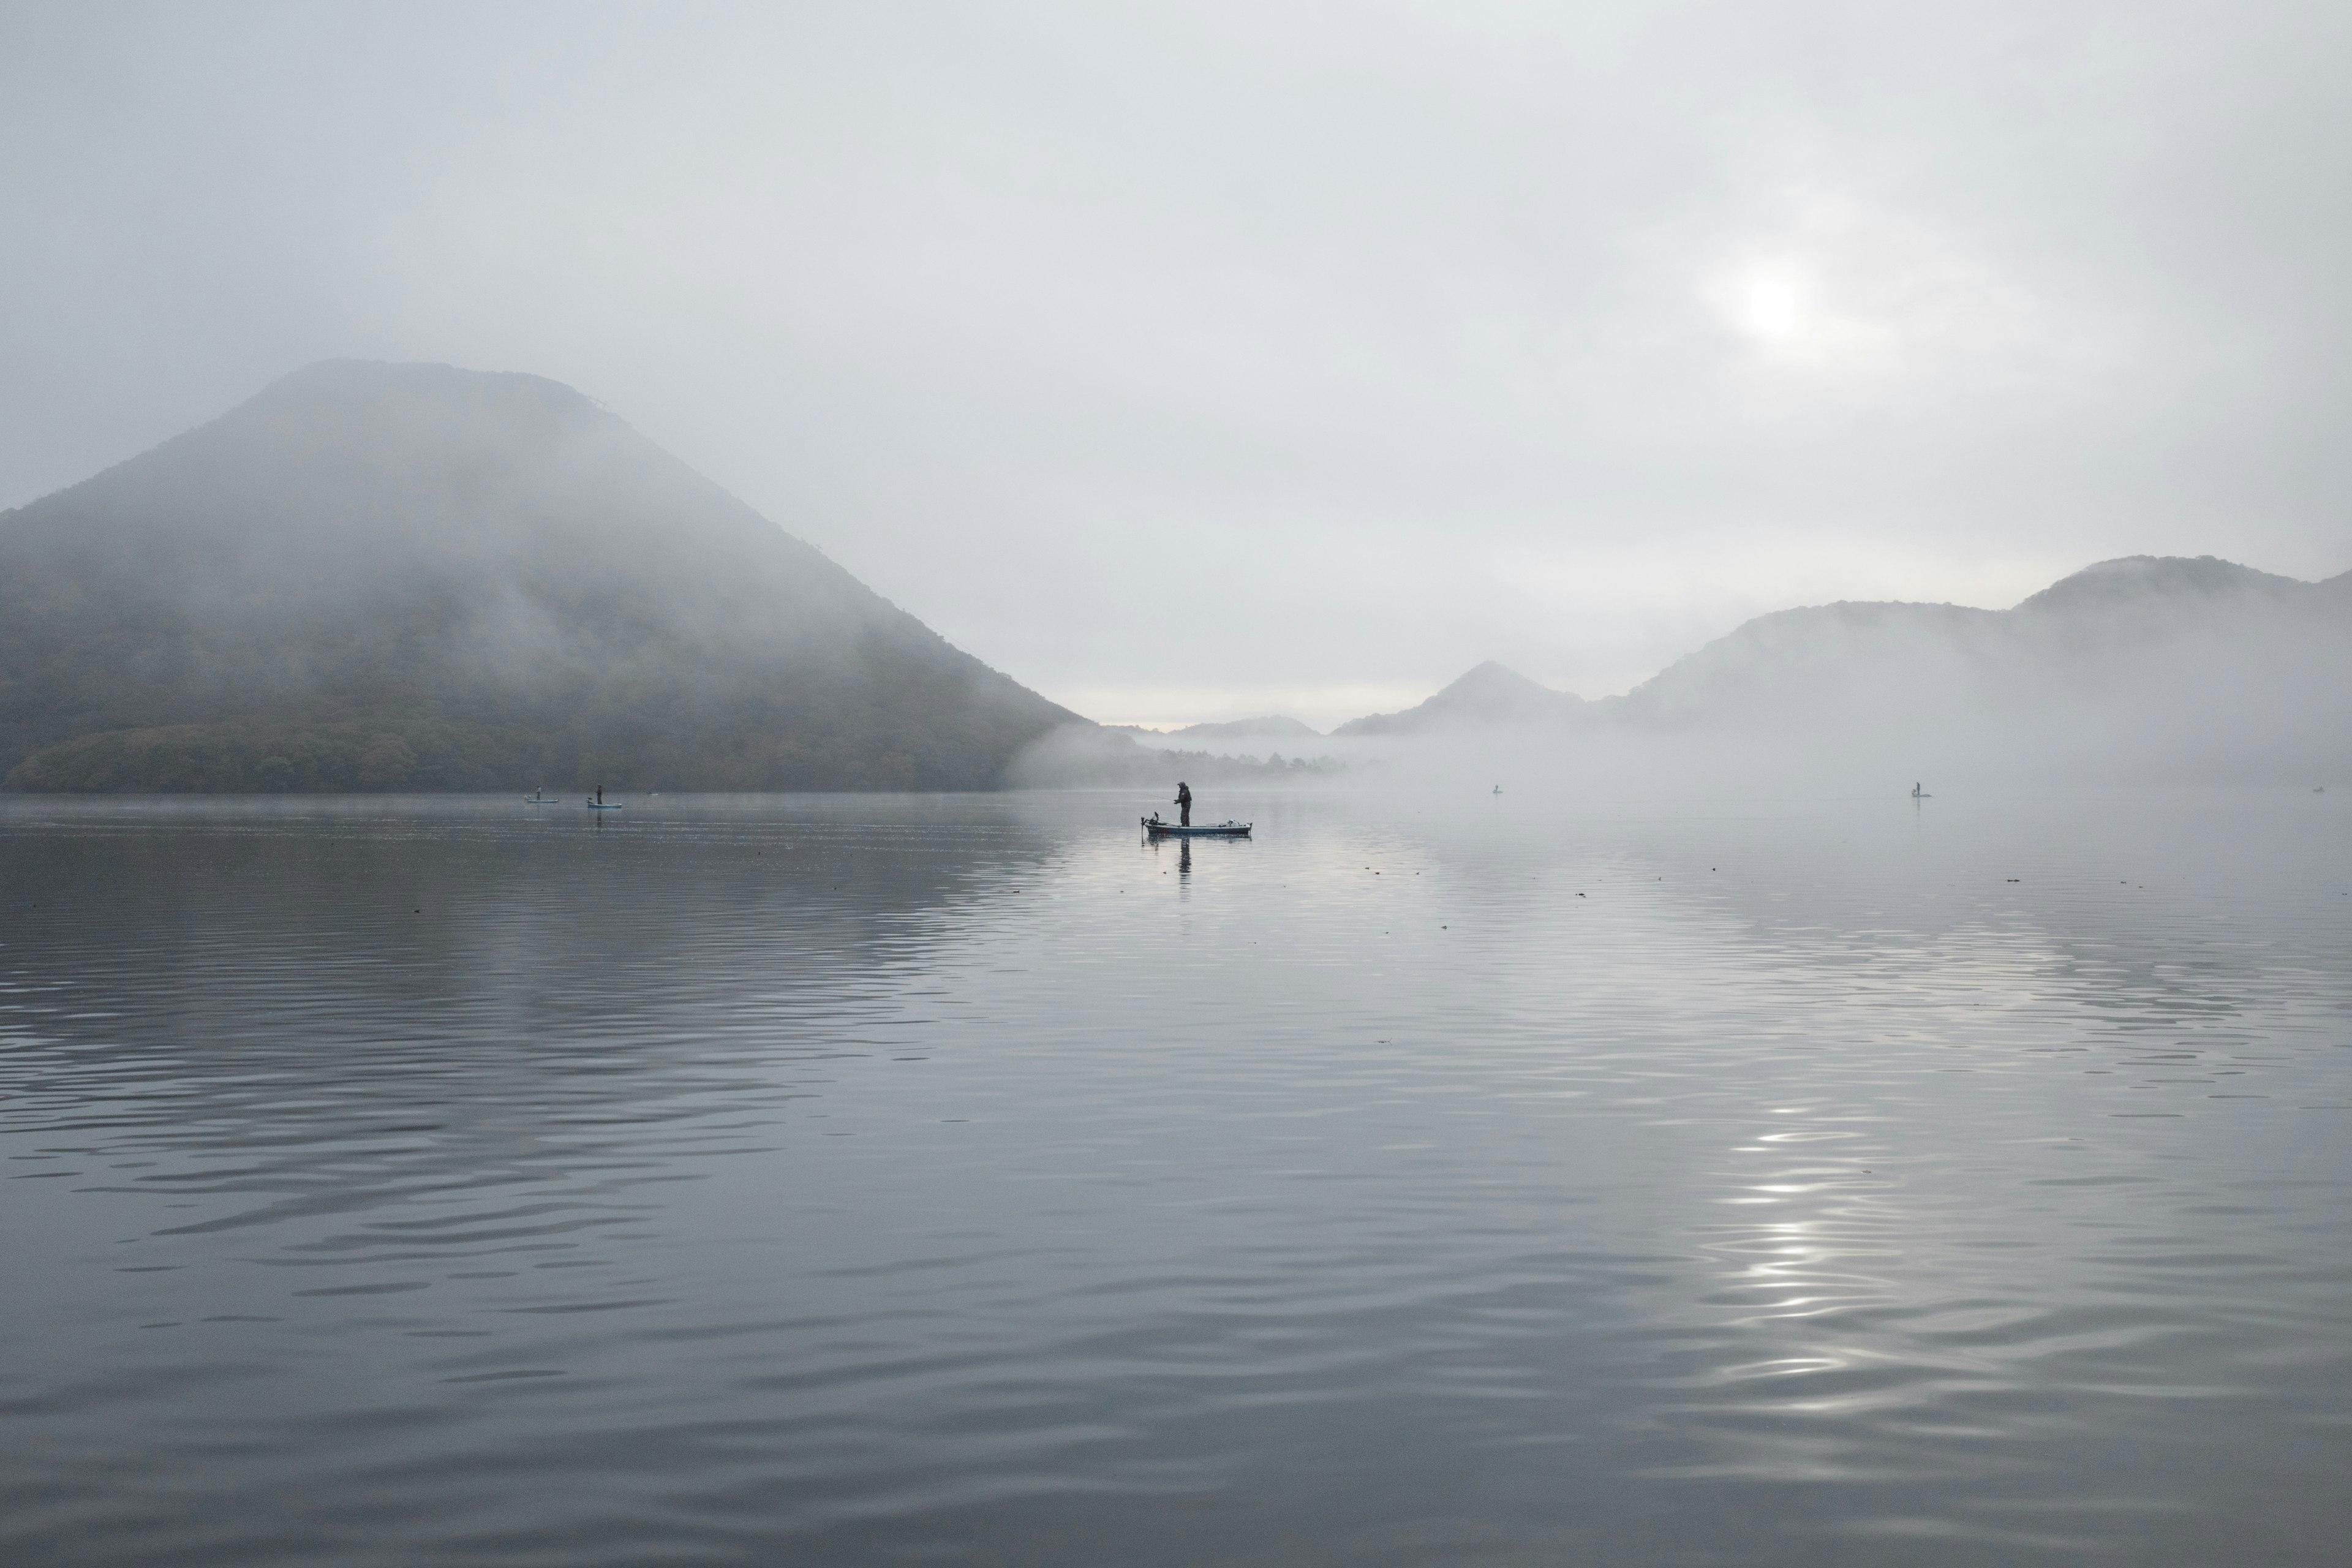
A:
[1333,555,2352,776]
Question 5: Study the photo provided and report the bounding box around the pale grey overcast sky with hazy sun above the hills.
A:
[0,0,2352,724]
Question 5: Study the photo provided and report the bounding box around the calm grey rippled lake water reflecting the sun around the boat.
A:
[0,790,2352,1568]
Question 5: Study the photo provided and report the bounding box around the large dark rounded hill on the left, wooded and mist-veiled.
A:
[0,360,1082,790]
